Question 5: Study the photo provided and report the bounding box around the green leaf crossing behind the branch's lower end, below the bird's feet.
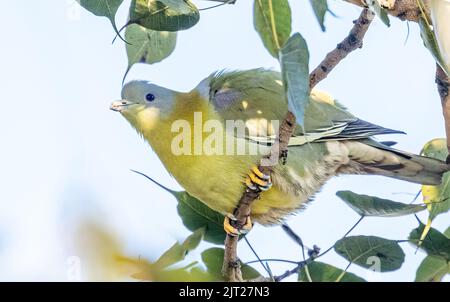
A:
[202,247,261,280]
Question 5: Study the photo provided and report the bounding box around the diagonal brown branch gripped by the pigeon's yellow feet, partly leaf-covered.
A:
[222,8,373,282]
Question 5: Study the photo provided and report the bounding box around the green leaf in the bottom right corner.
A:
[415,256,450,282]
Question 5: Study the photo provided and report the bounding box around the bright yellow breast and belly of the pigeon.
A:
[139,93,298,223]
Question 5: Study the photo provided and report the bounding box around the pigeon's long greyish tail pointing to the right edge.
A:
[340,140,450,185]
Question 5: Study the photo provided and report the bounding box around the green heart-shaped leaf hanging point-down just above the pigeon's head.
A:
[125,24,177,76]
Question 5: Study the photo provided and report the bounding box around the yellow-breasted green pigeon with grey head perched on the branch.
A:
[111,69,449,235]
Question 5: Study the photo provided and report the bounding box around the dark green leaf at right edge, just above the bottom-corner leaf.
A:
[408,223,450,261]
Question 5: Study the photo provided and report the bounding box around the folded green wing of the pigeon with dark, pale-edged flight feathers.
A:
[210,69,403,145]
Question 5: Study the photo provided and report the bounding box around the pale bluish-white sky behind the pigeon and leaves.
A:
[0,0,449,281]
